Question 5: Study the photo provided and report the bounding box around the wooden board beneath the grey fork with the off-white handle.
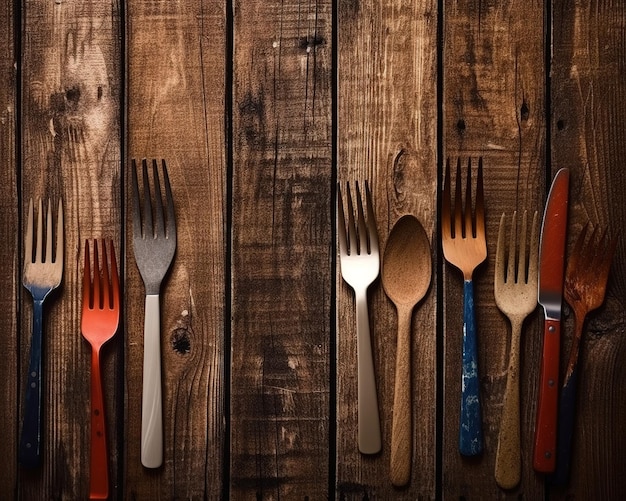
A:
[125,0,226,499]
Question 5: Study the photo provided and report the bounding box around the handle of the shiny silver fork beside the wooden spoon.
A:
[355,291,381,454]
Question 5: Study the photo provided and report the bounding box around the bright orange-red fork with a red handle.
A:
[80,241,120,499]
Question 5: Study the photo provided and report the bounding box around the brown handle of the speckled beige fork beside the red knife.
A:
[495,319,522,489]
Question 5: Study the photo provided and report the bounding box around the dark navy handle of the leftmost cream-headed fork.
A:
[19,300,43,468]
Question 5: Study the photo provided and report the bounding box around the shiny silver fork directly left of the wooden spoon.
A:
[337,181,381,454]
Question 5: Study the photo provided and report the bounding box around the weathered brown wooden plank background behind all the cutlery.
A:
[0,0,626,500]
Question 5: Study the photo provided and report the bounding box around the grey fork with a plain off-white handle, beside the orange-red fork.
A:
[132,159,176,468]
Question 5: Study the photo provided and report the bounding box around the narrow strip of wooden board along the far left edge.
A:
[0,2,21,499]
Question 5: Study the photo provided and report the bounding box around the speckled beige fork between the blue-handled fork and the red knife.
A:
[494,211,539,489]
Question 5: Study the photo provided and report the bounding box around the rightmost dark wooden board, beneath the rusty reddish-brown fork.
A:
[550,1,626,499]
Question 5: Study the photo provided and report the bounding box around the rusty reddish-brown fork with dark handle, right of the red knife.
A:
[549,223,617,485]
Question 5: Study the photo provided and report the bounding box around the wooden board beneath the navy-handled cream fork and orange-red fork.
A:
[19,0,122,499]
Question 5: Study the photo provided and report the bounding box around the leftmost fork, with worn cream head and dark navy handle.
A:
[19,199,64,468]
